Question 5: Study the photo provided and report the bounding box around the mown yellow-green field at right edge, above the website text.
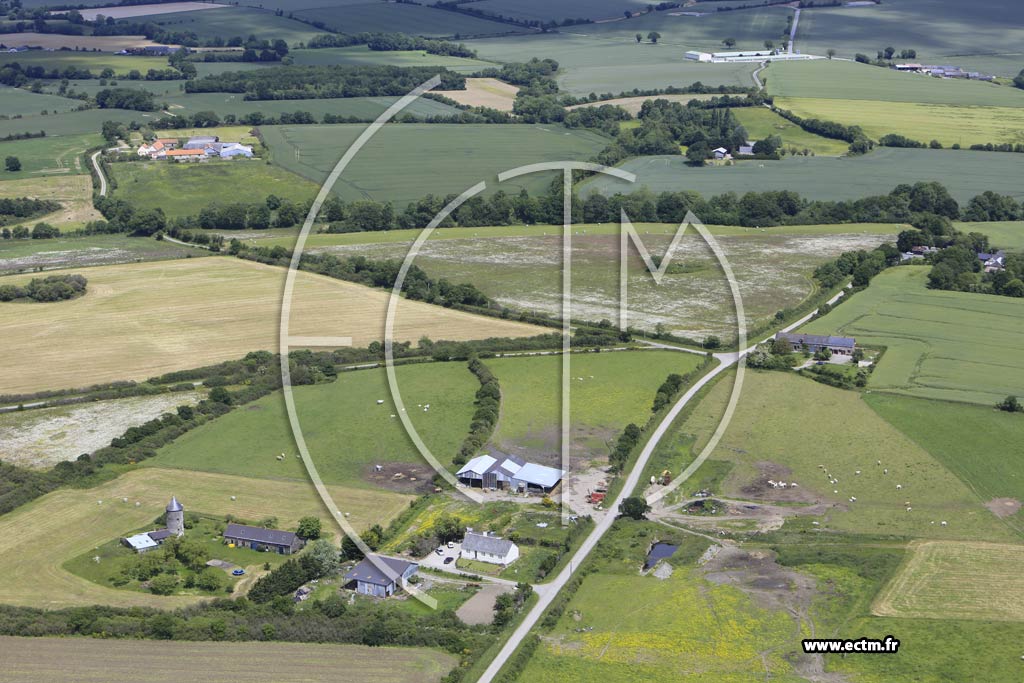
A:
[871,541,1024,622]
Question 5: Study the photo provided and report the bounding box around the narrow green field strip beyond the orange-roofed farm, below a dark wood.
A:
[167,92,458,121]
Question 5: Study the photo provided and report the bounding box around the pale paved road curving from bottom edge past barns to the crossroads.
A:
[477,290,846,683]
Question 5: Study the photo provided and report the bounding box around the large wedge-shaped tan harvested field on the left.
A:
[0,257,550,393]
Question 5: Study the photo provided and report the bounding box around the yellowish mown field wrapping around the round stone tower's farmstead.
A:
[0,468,412,608]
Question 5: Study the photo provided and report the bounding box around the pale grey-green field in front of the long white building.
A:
[466,33,757,95]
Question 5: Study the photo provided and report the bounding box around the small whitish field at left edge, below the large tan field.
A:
[0,392,203,468]
